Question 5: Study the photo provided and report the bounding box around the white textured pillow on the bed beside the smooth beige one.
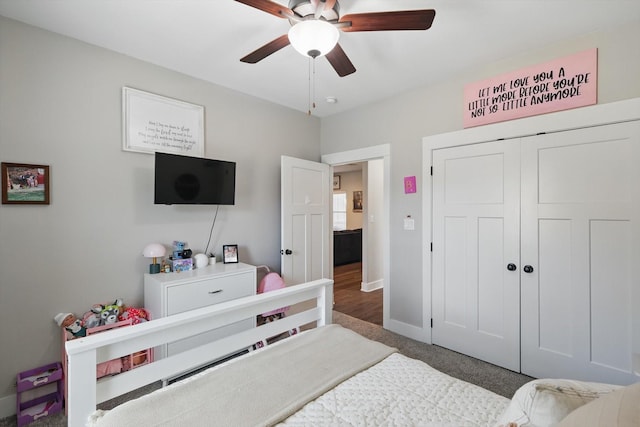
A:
[497,379,621,427]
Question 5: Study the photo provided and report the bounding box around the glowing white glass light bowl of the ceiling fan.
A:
[289,19,340,58]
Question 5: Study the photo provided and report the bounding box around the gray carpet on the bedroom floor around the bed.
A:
[0,311,532,427]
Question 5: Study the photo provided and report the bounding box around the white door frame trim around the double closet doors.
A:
[422,98,640,344]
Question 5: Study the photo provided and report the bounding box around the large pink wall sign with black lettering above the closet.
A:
[464,49,598,128]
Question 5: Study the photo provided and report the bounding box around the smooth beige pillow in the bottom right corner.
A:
[558,383,640,427]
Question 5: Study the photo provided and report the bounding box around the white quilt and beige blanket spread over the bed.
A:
[93,325,509,427]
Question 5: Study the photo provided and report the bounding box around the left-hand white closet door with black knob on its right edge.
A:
[432,141,520,371]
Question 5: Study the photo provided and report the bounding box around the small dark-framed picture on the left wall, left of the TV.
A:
[2,162,49,205]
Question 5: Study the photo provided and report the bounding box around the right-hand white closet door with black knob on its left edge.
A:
[521,122,640,383]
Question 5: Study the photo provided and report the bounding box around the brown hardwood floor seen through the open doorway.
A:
[333,262,383,326]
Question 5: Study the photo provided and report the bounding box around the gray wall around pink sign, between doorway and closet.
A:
[321,21,640,328]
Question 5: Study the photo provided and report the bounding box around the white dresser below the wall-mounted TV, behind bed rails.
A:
[144,263,257,359]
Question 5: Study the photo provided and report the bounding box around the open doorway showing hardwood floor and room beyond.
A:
[332,160,384,326]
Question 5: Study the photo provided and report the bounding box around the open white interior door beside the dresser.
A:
[281,156,333,285]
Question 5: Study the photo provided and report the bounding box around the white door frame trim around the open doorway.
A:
[321,144,392,329]
